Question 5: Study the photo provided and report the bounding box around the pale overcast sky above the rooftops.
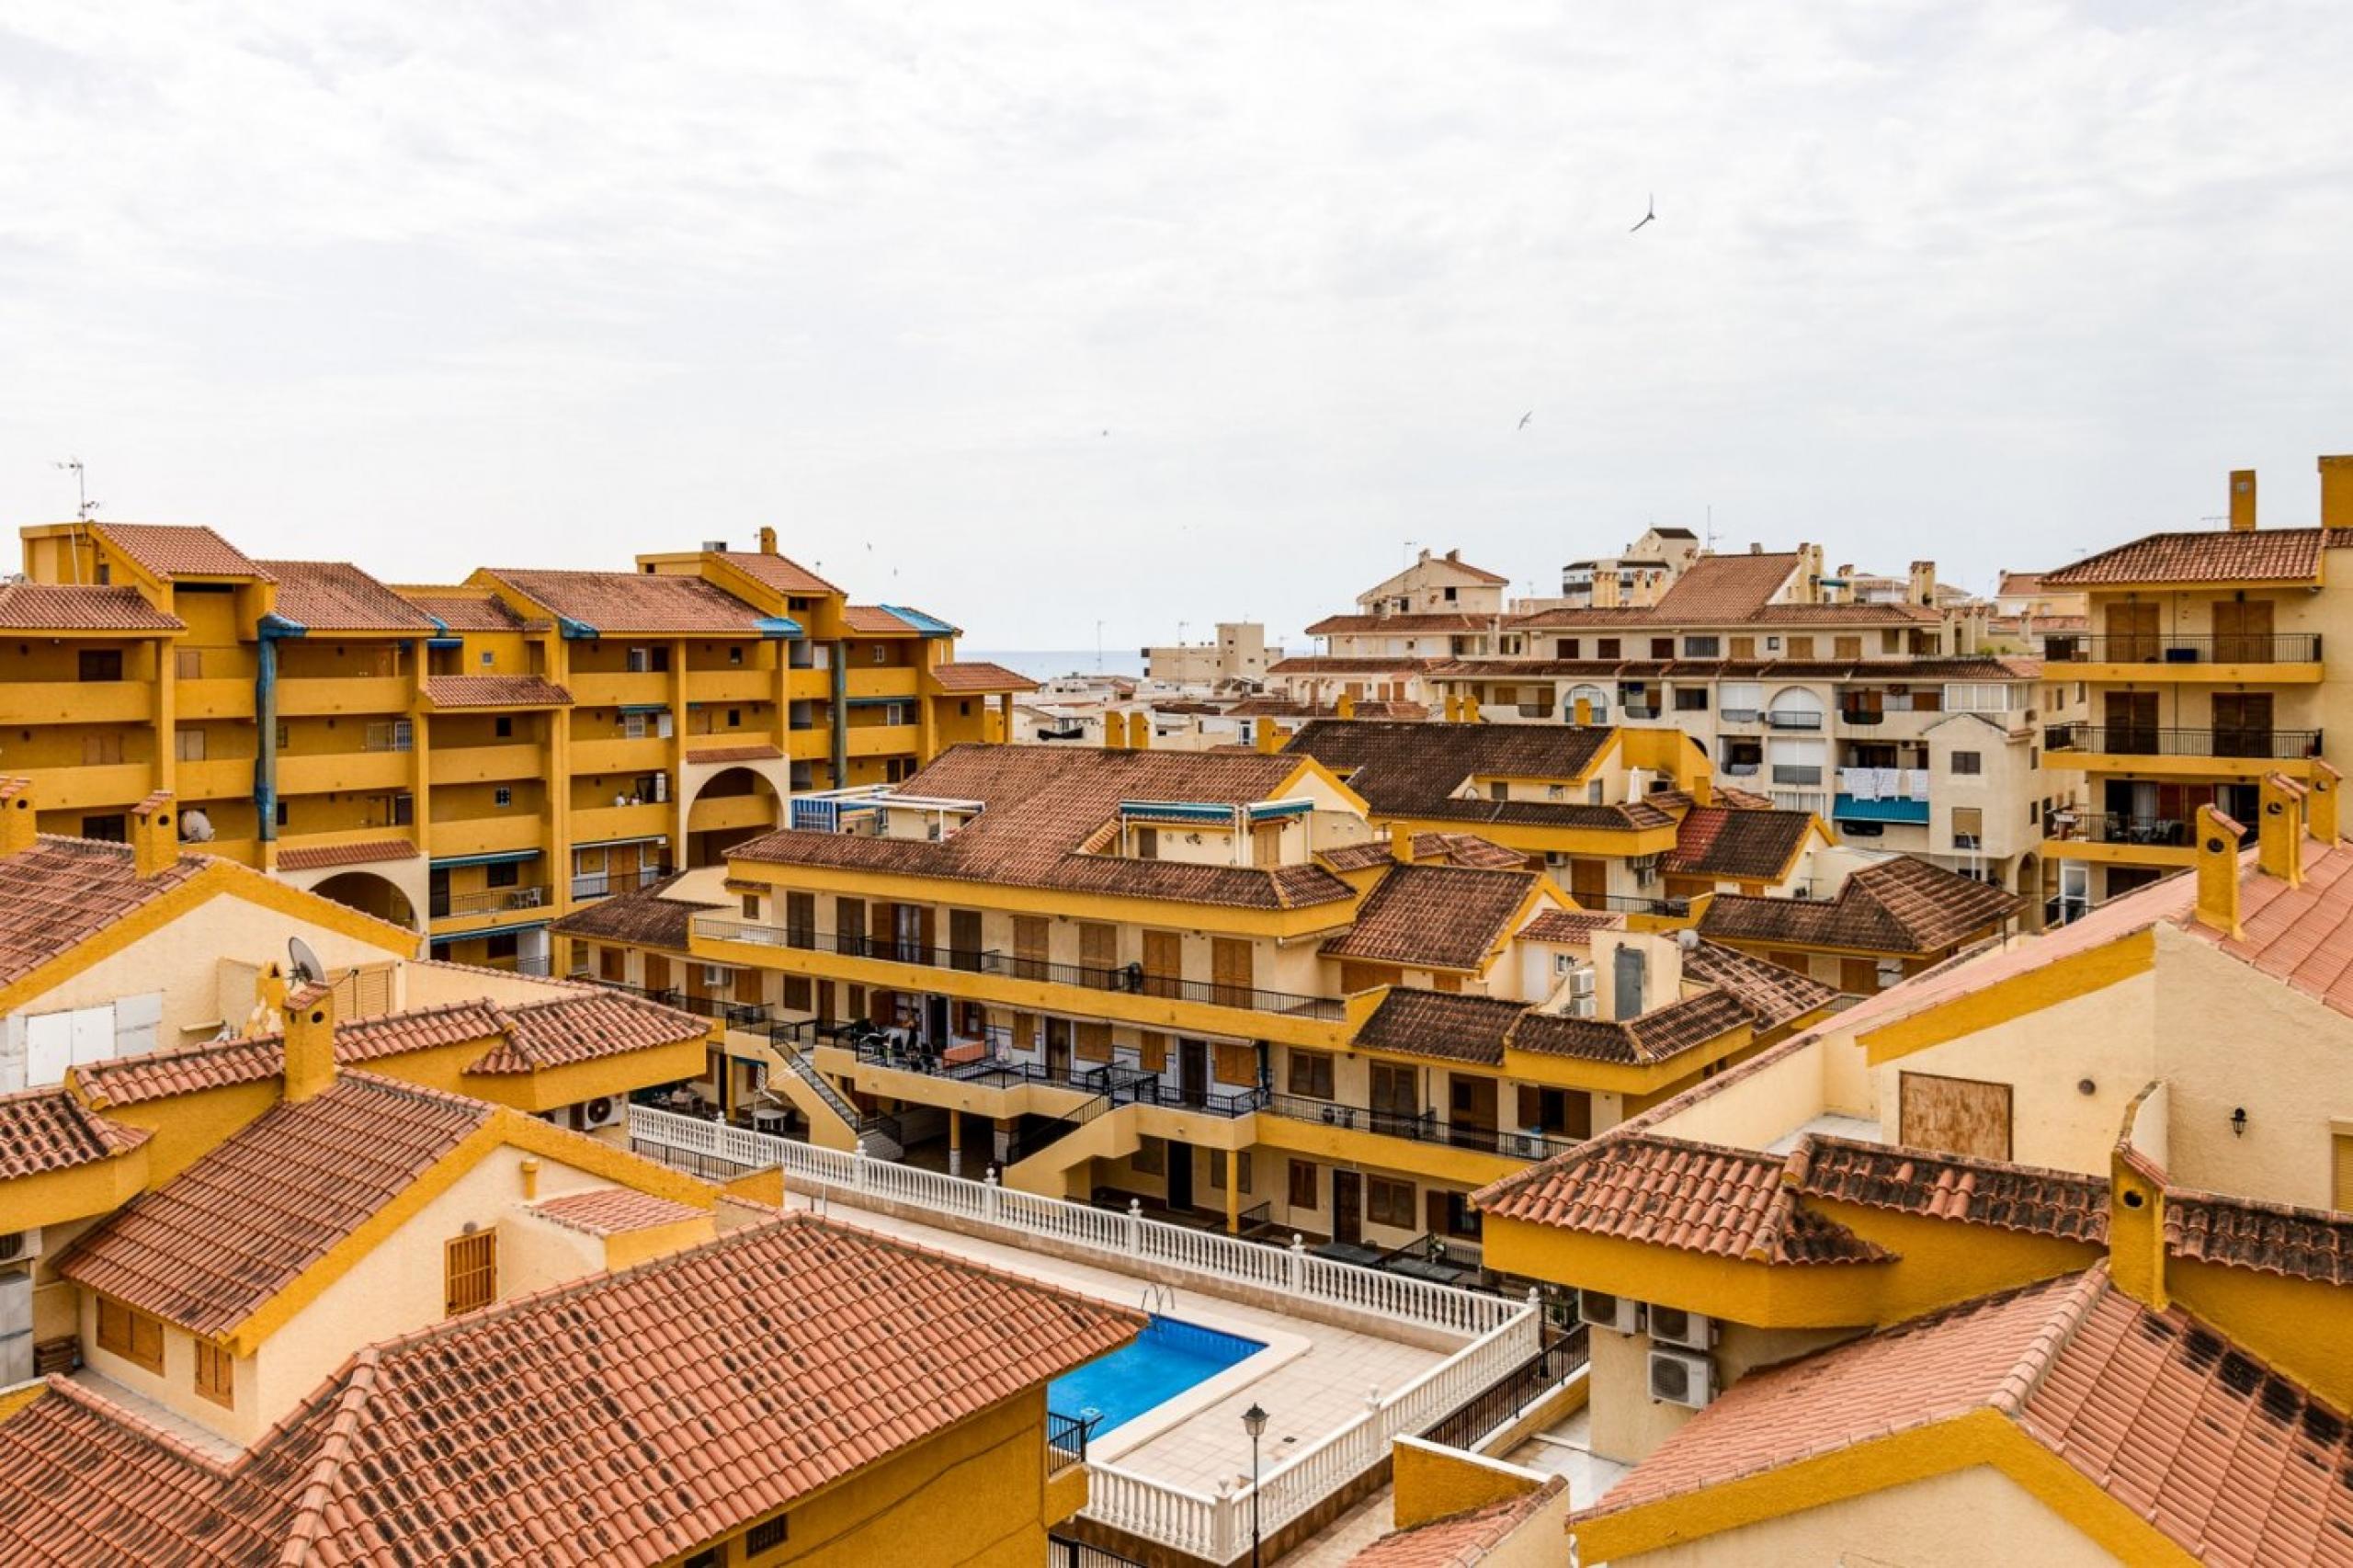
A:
[0,0,2353,647]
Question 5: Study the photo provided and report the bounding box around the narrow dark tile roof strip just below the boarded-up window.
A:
[1789,1132,2109,1245]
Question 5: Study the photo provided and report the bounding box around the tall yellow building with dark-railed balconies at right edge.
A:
[2042,457,2353,918]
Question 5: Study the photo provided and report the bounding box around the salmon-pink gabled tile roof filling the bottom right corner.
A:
[1588,1267,2353,1568]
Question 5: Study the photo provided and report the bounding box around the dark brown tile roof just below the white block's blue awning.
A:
[1699,855,2024,953]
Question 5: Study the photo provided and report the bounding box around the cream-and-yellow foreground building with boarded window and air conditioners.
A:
[1478,763,2353,1568]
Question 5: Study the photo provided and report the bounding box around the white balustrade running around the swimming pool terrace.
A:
[629,1104,1541,1563]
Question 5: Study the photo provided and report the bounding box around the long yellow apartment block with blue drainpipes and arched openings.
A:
[0,523,1030,972]
